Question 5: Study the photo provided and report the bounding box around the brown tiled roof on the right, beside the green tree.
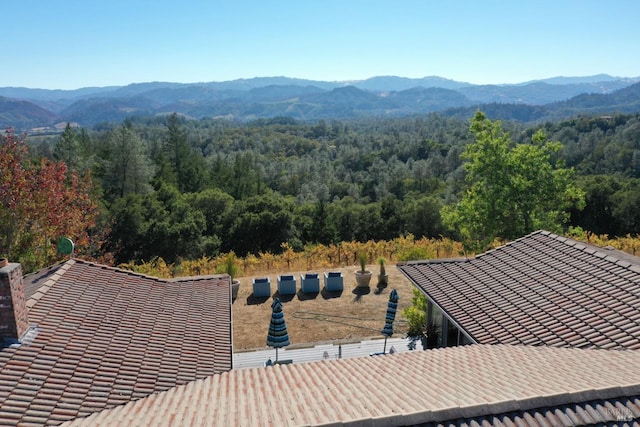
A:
[398,231,640,349]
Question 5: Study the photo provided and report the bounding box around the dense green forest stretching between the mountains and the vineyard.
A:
[0,109,640,267]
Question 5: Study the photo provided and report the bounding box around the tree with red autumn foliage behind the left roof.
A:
[0,129,98,271]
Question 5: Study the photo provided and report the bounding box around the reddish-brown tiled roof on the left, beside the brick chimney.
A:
[0,260,232,425]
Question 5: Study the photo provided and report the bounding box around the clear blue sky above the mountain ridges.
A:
[5,0,640,89]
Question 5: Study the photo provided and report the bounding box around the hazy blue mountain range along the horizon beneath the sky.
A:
[0,74,640,131]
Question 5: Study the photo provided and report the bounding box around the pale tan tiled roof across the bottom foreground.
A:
[61,345,640,426]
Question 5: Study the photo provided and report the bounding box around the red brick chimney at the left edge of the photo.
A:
[0,259,29,341]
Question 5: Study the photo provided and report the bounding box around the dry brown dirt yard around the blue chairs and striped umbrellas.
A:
[233,264,413,352]
